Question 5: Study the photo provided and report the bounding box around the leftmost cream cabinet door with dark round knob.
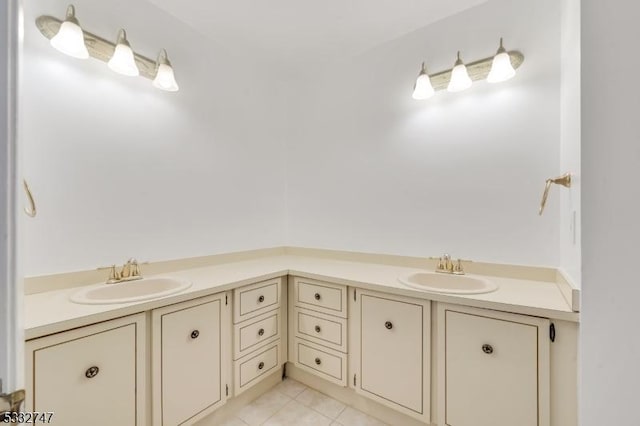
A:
[25,314,146,426]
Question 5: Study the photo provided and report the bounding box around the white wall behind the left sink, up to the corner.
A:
[22,0,285,275]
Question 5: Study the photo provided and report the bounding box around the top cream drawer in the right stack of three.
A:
[294,277,347,318]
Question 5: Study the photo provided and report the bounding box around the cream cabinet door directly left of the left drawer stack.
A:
[152,293,231,426]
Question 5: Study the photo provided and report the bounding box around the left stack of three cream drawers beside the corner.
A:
[233,278,284,395]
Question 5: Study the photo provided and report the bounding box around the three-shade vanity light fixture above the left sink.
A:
[36,5,178,92]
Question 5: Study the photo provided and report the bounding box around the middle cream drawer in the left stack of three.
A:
[233,310,281,359]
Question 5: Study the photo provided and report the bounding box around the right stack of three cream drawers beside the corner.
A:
[291,277,347,386]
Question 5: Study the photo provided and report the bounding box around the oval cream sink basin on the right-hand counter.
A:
[398,272,498,294]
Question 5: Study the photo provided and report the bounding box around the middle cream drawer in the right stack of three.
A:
[294,308,347,352]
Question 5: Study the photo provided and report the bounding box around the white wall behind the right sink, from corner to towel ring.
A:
[287,0,561,266]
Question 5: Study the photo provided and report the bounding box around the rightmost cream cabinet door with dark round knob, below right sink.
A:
[438,304,550,426]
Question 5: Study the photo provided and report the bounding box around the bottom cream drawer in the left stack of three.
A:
[234,343,281,395]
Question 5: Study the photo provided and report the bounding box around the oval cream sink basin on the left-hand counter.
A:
[70,277,191,305]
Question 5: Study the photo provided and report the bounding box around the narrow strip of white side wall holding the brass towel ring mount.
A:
[557,0,582,286]
